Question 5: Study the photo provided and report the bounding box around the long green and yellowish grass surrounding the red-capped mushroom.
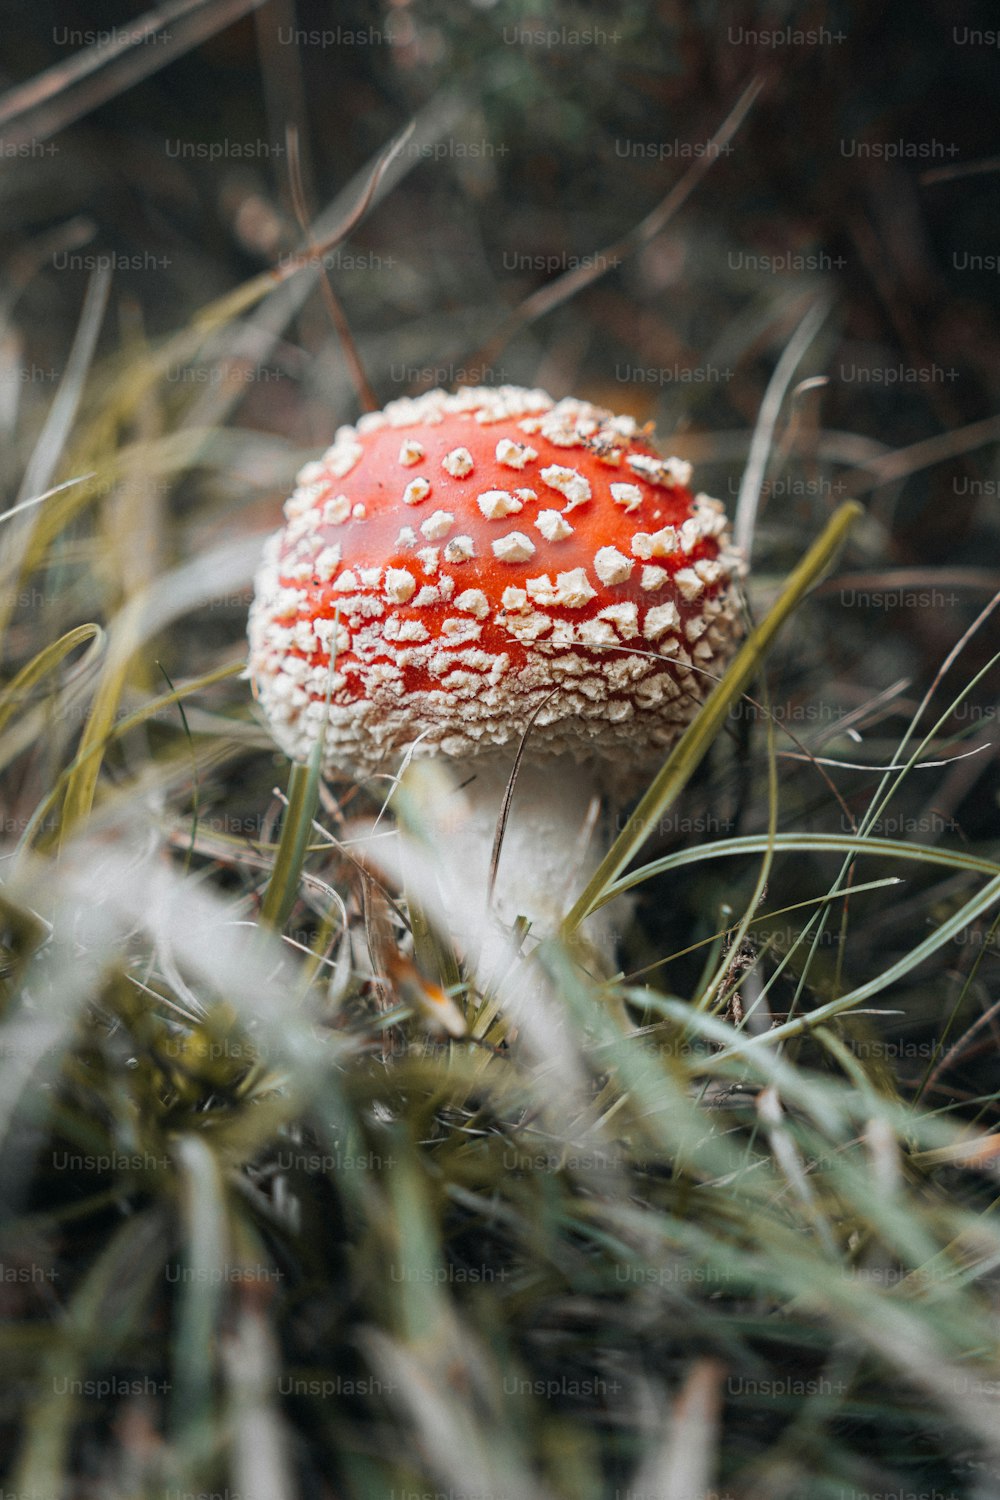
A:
[0,12,1000,1500]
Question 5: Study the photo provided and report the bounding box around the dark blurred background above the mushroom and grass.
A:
[0,0,1000,468]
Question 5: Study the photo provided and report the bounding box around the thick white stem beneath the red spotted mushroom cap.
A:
[419,756,627,972]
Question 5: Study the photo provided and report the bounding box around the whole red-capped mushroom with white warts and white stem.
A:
[249,386,739,936]
